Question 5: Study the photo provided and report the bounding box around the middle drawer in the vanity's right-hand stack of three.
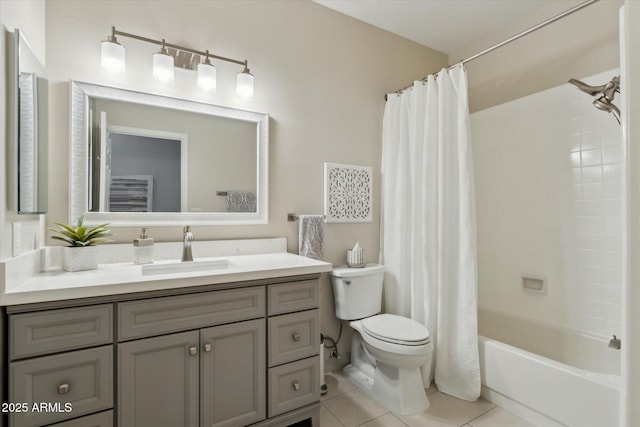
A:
[269,310,320,366]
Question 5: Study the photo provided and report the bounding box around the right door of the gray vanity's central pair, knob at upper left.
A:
[200,319,266,427]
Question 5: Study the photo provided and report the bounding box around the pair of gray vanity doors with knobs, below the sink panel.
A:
[118,319,265,427]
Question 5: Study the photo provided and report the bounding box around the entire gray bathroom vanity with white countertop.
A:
[2,239,331,427]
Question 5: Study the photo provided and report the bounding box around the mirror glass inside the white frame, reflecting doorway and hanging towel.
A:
[89,98,257,212]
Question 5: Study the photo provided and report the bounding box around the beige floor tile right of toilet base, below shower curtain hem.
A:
[400,392,495,427]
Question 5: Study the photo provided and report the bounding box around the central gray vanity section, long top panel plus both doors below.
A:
[118,286,266,427]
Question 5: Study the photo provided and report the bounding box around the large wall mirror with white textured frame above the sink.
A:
[70,81,269,226]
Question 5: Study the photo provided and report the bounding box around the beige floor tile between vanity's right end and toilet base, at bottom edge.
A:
[322,389,388,427]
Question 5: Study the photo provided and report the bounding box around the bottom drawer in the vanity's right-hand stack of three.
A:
[269,356,320,417]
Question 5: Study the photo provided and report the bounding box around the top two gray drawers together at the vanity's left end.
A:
[8,304,114,427]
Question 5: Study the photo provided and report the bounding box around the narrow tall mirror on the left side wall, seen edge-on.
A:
[15,29,49,214]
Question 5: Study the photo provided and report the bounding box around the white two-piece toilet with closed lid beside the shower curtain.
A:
[331,264,433,415]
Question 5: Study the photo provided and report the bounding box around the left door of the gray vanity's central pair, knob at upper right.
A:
[118,331,200,427]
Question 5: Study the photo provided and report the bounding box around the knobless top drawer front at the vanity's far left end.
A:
[9,304,113,360]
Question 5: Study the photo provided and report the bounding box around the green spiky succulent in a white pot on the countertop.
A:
[49,215,111,271]
